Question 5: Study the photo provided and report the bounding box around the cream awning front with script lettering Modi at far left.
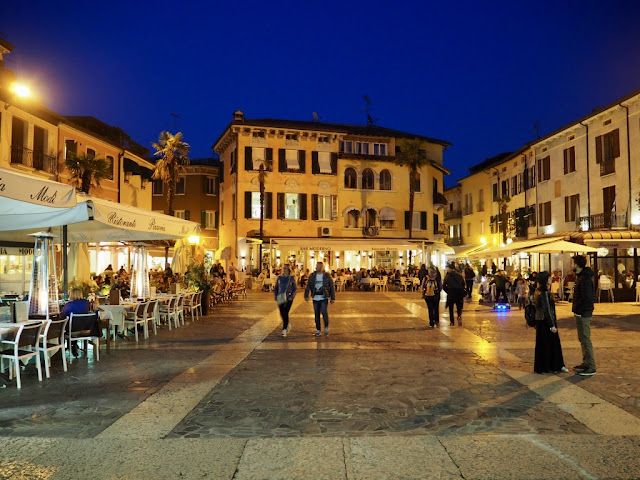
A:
[0,168,76,211]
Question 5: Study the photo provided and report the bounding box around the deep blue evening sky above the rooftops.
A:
[0,0,640,186]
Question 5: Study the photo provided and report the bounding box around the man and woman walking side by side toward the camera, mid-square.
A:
[273,262,336,337]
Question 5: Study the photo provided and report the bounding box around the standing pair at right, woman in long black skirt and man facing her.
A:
[533,255,596,376]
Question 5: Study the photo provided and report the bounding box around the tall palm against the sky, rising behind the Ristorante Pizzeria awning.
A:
[151,131,191,215]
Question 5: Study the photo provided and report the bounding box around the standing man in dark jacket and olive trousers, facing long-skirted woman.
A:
[572,255,596,376]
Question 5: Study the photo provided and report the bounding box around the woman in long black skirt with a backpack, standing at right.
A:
[533,272,568,373]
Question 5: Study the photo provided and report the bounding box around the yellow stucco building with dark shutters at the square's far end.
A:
[213,111,449,268]
